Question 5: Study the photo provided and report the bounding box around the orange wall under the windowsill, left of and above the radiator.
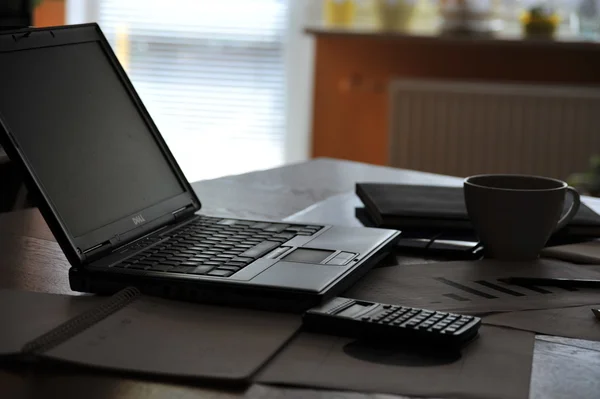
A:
[308,30,600,165]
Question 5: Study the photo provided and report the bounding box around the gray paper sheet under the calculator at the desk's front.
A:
[257,326,535,399]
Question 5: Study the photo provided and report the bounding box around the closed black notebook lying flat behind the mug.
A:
[356,183,600,237]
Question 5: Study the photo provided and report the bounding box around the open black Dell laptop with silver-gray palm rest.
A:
[0,24,400,311]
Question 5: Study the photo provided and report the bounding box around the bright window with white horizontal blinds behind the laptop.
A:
[97,0,288,181]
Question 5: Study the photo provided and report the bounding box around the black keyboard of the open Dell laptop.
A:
[113,216,322,277]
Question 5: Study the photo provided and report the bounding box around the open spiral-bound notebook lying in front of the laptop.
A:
[0,288,301,381]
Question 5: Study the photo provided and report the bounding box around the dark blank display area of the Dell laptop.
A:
[0,42,184,237]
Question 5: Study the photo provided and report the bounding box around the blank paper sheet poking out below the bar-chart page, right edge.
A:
[483,301,600,341]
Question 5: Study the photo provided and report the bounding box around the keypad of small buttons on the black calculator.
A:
[362,305,475,334]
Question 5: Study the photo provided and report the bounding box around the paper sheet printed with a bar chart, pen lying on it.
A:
[343,260,600,313]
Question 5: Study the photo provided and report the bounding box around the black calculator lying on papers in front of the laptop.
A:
[303,297,481,348]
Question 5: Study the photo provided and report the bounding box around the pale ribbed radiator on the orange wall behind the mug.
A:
[389,80,600,179]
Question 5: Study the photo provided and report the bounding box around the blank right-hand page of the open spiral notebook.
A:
[45,297,301,380]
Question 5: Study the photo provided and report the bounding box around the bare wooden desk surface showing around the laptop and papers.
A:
[0,159,600,399]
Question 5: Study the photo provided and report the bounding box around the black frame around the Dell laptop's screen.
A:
[0,23,201,264]
